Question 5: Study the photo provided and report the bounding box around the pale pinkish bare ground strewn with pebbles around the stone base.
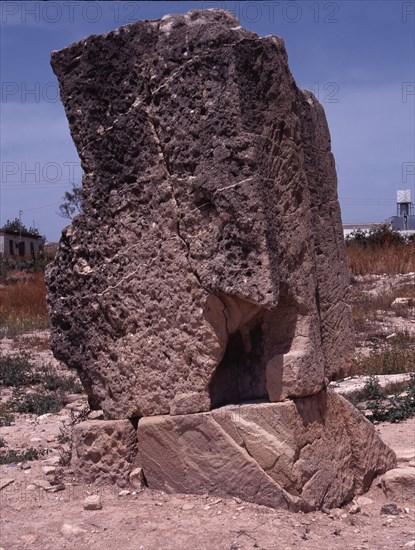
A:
[0,279,415,550]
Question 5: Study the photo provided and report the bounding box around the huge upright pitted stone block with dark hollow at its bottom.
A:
[48,10,353,418]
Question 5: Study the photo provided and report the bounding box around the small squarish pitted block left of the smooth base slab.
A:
[71,420,137,488]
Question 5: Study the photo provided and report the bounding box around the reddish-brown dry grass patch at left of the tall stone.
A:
[0,273,49,335]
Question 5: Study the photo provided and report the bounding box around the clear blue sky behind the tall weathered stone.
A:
[0,0,415,240]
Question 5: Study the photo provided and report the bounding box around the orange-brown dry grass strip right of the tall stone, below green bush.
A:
[347,241,415,275]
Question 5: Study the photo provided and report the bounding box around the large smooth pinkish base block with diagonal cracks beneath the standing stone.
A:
[137,390,396,510]
